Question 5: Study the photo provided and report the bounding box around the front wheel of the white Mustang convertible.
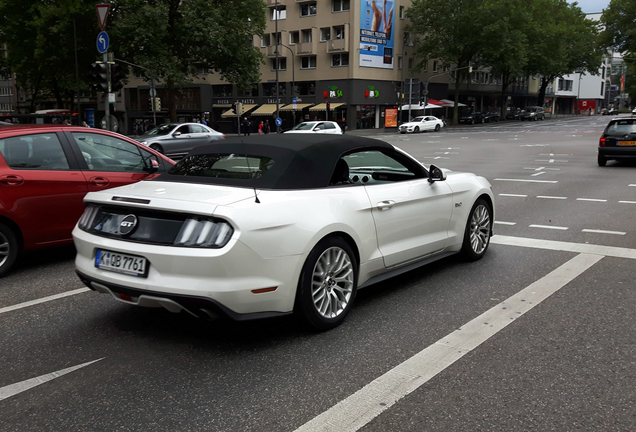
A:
[461,198,493,261]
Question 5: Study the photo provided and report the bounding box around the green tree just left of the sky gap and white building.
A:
[525,0,603,106]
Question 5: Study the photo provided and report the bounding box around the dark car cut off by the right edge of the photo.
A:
[598,117,636,166]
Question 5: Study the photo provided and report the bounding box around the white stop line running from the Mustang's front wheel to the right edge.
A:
[490,235,636,260]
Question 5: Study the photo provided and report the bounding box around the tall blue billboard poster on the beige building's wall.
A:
[360,0,394,69]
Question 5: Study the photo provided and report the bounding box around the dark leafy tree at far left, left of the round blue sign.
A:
[0,0,97,111]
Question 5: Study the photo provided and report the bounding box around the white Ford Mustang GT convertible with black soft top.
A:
[73,135,495,330]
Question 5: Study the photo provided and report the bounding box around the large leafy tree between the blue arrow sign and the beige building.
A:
[109,0,266,121]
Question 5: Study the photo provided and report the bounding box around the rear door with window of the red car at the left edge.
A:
[0,132,88,248]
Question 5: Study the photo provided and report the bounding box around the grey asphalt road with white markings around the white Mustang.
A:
[0,117,636,431]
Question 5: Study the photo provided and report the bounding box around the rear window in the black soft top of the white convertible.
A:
[169,154,274,180]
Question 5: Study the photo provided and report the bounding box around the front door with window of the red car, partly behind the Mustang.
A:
[66,131,165,191]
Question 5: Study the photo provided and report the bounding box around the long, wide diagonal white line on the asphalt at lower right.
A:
[296,254,602,432]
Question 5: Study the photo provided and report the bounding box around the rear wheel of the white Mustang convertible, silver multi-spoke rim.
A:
[294,237,358,331]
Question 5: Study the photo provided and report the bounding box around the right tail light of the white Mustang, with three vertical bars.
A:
[174,218,234,248]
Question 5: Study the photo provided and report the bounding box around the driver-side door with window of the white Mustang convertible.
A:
[343,150,453,267]
